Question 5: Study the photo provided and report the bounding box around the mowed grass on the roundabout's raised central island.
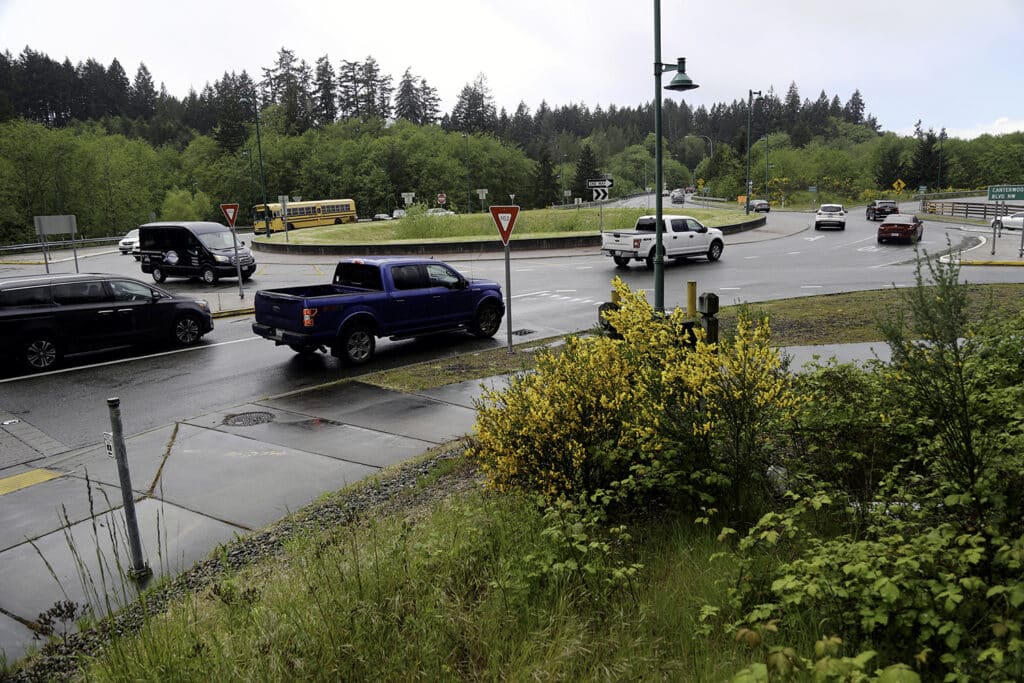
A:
[256,205,760,245]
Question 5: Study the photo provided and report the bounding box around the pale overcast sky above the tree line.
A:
[0,0,1024,138]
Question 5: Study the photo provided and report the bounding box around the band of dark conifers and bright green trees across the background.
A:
[0,47,1024,242]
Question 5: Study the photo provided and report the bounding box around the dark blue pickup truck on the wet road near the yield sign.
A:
[253,257,505,365]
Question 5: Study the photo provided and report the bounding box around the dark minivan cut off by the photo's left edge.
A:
[0,272,213,371]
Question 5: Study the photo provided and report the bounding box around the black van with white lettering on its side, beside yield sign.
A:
[138,221,256,285]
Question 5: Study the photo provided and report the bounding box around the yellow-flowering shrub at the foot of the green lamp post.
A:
[469,278,799,518]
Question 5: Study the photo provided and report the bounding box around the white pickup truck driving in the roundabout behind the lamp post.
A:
[601,216,725,268]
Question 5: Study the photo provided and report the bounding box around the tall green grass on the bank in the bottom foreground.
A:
[84,464,761,681]
